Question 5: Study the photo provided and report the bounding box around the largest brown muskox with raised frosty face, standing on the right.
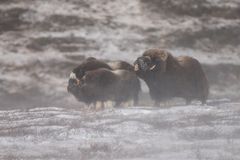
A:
[134,49,209,105]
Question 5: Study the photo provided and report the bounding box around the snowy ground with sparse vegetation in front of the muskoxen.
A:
[0,103,240,160]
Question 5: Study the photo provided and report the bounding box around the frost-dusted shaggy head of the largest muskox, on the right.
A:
[134,49,169,74]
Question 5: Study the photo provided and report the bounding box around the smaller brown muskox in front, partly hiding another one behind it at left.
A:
[68,68,141,107]
